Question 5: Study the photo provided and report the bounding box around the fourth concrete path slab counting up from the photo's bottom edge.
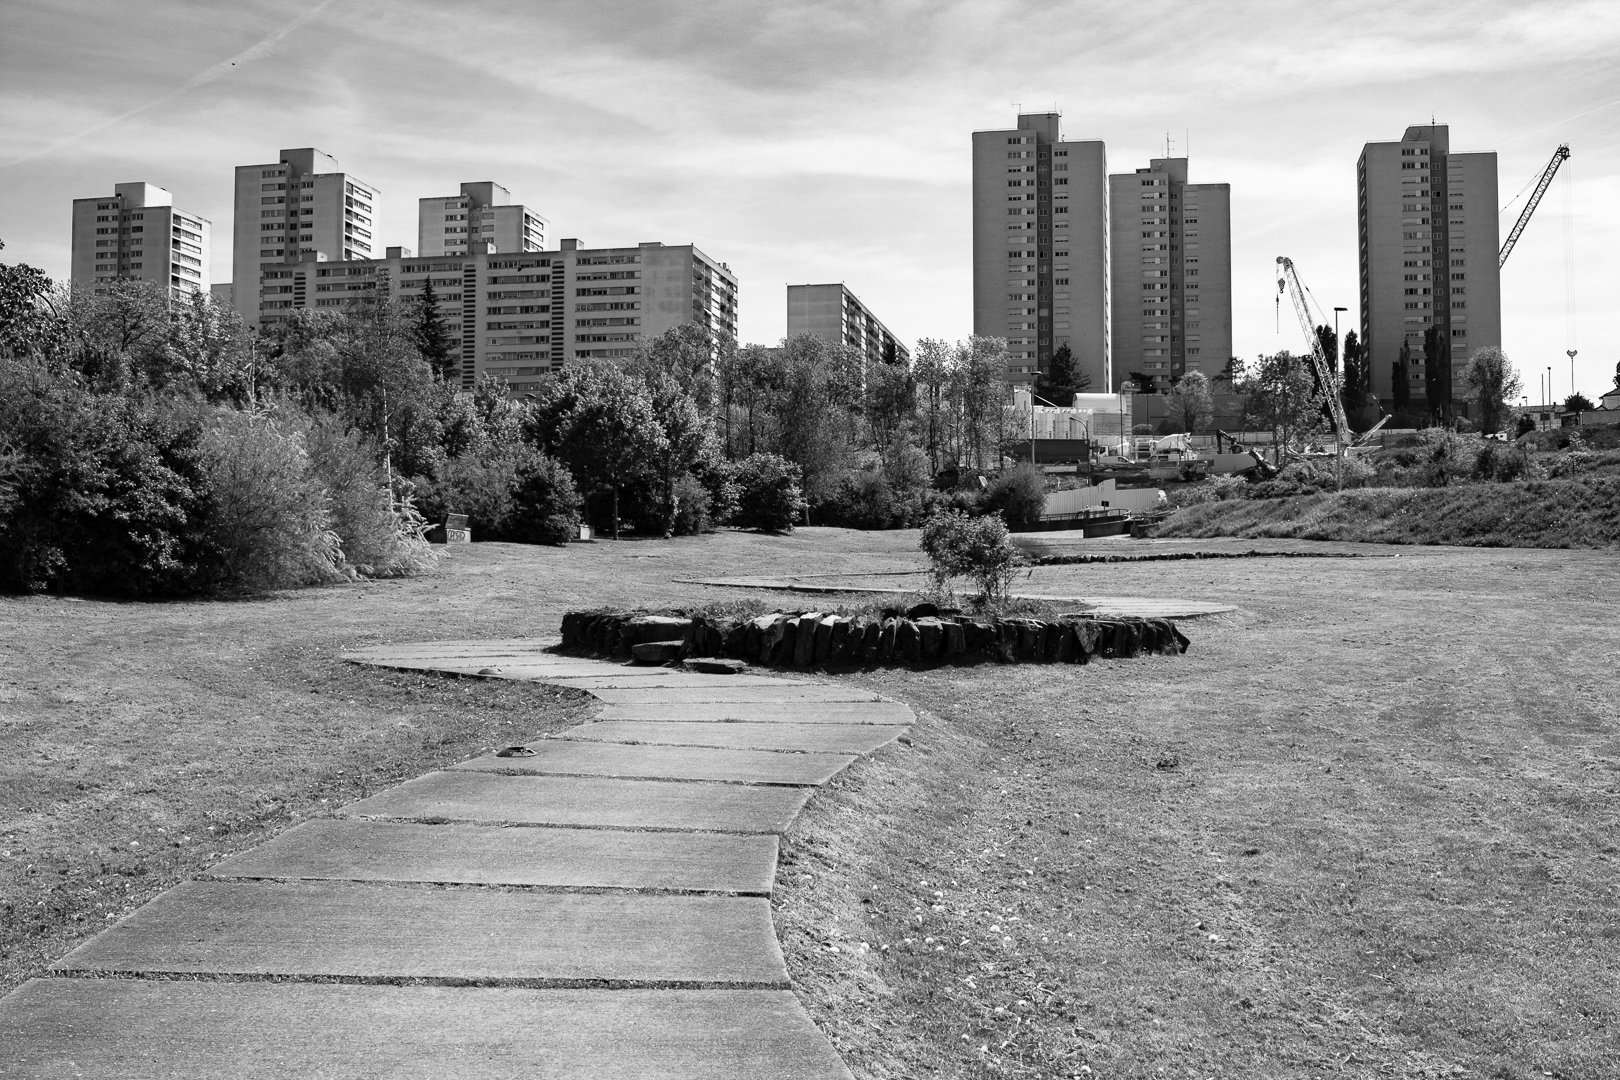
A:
[343,771,813,832]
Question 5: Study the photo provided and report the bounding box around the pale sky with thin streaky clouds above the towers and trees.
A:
[0,0,1620,400]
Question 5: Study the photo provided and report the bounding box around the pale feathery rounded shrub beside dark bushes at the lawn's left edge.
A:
[203,413,343,591]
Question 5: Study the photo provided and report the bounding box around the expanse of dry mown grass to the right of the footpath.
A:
[778,552,1620,1080]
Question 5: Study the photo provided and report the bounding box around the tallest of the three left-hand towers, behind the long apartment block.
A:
[232,147,377,325]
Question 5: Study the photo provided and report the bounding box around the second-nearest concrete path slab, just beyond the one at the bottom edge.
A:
[52,881,787,989]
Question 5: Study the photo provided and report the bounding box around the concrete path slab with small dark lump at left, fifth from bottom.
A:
[452,738,854,787]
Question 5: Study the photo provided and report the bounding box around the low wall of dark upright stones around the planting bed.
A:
[559,609,1189,669]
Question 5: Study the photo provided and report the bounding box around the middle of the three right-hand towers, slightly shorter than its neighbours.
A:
[1108,157,1231,390]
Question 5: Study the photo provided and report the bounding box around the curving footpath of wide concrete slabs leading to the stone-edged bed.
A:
[0,640,914,1080]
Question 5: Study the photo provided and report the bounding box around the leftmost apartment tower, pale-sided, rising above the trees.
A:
[71,183,212,291]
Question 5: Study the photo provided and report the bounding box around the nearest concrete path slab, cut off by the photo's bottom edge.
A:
[0,978,851,1080]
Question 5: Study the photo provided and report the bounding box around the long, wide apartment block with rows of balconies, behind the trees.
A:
[252,240,737,390]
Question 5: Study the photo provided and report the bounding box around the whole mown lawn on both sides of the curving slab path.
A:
[0,529,1620,1080]
